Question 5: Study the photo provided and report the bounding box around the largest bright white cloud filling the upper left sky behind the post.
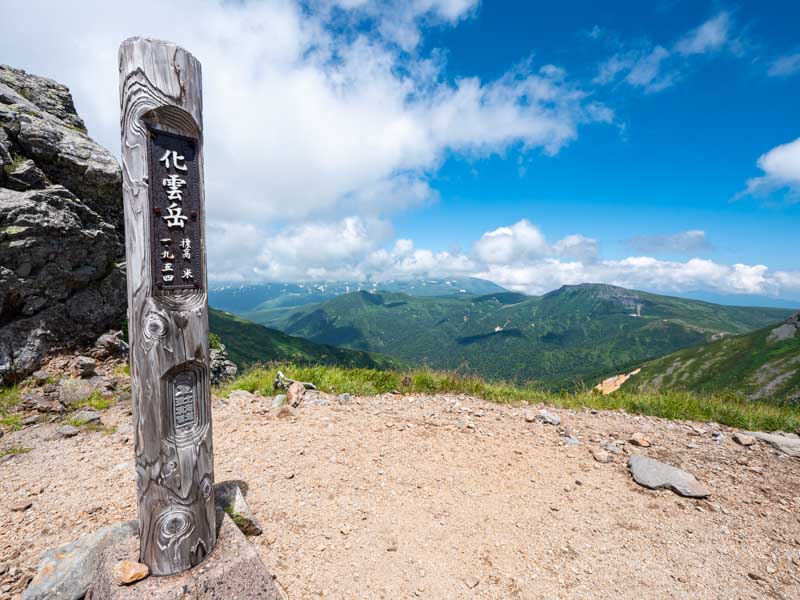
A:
[0,0,613,272]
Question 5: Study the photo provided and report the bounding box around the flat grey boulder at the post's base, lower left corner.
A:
[22,521,139,600]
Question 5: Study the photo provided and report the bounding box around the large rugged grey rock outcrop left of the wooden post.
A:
[0,65,126,383]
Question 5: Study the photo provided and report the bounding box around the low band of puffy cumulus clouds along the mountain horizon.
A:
[209,216,800,297]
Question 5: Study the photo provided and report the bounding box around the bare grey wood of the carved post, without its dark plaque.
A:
[119,37,215,575]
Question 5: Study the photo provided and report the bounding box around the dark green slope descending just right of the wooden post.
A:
[208,308,398,369]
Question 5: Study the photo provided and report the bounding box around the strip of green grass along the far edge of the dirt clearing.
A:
[218,363,800,431]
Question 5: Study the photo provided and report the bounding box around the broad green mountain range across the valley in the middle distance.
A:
[268,284,791,387]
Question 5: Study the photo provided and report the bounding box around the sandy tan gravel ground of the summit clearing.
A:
[0,393,800,600]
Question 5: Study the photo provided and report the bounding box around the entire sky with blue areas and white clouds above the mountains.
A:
[0,0,800,300]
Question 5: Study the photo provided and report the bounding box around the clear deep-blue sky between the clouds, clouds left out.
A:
[406,1,800,269]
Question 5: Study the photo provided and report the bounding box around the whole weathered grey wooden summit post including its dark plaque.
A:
[119,37,216,575]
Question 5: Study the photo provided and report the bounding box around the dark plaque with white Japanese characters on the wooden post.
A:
[148,129,203,294]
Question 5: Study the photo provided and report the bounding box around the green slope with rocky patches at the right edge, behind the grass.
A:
[622,313,800,404]
